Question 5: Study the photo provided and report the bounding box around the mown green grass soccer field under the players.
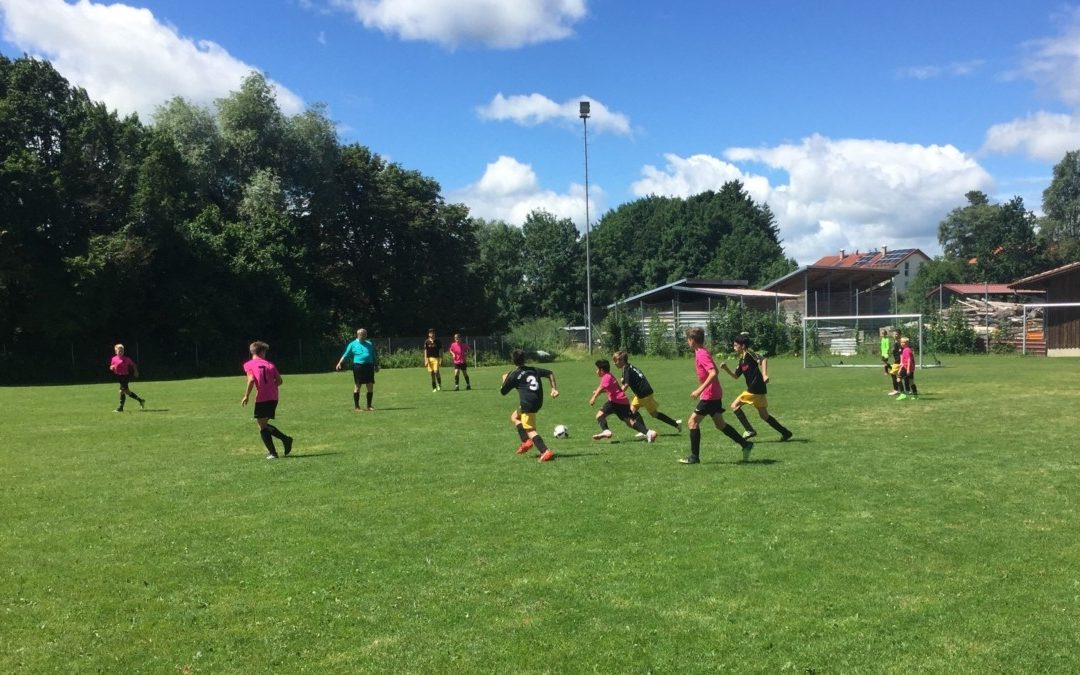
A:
[0,353,1080,673]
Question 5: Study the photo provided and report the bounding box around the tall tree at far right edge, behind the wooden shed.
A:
[1039,150,1080,265]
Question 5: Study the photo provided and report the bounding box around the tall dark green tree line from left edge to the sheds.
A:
[0,56,794,380]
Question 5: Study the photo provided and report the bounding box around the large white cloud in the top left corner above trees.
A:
[0,0,303,120]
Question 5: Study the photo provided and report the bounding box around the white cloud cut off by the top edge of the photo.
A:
[332,0,585,49]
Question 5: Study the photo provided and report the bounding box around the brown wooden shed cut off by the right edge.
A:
[1009,261,1080,356]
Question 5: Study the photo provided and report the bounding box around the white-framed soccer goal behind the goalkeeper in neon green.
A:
[802,314,941,368]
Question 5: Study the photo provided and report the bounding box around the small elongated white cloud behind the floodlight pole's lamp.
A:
[476,92,631,136]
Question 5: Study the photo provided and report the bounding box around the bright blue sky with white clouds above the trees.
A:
[0,0,1080,264]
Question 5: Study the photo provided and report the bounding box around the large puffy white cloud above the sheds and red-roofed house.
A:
[632,135,993,264]
